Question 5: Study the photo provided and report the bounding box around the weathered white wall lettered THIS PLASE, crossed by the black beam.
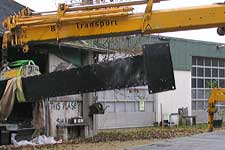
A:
[48,54,82,137]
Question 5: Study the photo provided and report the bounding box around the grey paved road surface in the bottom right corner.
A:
[127,131,225,150]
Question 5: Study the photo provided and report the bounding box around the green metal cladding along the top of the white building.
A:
[151,36,225,70]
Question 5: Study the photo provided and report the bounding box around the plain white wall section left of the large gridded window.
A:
[156,71,191,122]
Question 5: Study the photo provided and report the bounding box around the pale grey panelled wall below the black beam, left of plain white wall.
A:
[95,86,156,129]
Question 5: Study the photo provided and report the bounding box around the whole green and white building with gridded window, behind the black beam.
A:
[96,35,225,129]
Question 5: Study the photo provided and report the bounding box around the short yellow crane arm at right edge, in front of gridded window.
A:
[208,88,225,132]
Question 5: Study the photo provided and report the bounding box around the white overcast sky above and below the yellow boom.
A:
[15,0,225,43]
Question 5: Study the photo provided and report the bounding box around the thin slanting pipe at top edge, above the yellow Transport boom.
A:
[67,0,147,11]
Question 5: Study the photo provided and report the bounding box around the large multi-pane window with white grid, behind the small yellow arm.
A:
[191,57,225,110]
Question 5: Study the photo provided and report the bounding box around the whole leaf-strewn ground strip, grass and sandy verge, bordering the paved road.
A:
[0,124,225,150]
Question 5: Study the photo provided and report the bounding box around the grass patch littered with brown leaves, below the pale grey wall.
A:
[91,124,211,142]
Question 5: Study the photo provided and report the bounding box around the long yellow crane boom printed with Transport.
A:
[2,0,225,52]
